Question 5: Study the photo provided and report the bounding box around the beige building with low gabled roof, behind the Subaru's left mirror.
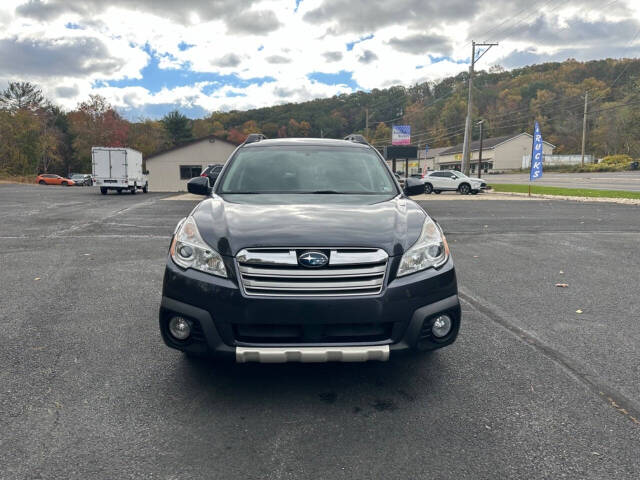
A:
[146,135,237,192]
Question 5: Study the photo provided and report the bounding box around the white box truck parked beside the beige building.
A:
[91,147,149,195]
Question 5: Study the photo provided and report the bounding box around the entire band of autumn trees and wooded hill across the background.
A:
[0,59,640,175]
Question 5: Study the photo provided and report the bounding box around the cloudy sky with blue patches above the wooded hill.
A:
[0,0,640,119]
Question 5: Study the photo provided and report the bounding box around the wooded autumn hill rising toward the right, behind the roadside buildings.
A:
[198,59,640,156]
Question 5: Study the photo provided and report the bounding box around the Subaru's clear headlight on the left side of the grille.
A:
[169,217,227,278]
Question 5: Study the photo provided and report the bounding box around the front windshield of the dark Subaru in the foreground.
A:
[219,146,397,195]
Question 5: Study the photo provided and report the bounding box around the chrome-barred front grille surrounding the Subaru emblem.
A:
[236,248,388,296]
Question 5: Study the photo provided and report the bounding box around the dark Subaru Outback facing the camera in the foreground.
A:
[160,135,460,362]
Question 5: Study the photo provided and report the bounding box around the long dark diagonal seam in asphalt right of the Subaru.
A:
[458,287,640,426]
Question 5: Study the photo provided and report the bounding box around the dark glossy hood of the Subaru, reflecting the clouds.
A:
[192,195,426,256]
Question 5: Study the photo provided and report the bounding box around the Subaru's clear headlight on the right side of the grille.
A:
[396,217,449,277]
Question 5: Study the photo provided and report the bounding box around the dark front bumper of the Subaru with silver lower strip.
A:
[160,257,461,362]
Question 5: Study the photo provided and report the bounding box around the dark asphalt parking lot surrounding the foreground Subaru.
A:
[0,185,640,479]
